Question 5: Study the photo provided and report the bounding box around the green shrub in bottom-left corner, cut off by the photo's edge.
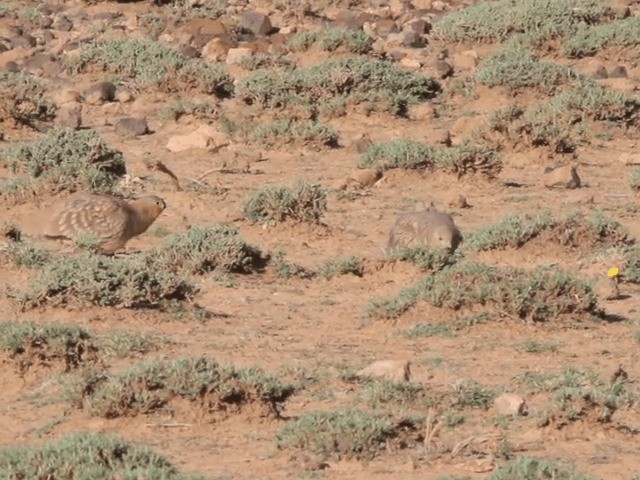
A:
[0,433,205,480]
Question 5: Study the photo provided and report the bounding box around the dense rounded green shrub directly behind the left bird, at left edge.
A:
[0,128,126,195]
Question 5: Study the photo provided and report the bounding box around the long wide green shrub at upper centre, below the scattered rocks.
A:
[236,56,441,113]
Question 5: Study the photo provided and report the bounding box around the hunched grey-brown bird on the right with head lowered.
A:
[387,206,462,252]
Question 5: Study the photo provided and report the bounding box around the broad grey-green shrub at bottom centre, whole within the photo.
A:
[276,408,417,459]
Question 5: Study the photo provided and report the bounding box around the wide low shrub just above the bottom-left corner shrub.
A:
[70,357,294,418]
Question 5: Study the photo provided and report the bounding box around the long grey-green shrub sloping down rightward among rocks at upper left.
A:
[66,38,233,97]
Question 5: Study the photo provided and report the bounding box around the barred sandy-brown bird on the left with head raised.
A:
[42,193,166,253]
